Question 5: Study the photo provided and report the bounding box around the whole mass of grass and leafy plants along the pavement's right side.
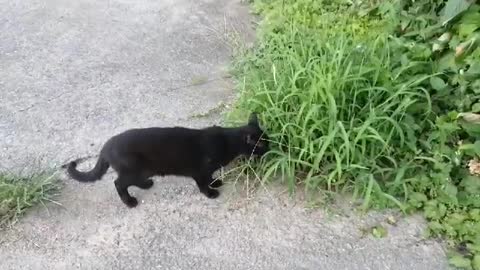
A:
[229,0,480,270]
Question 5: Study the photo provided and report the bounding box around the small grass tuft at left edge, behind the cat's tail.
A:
[0,172,59,228]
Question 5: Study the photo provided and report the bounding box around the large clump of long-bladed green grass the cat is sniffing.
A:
[229,12,432,207]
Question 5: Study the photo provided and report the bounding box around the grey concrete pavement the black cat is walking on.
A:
[0,0,447,270]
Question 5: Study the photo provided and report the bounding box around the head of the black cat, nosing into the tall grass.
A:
[243,113,270,156]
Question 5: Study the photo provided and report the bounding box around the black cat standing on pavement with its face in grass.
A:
[67,113,269,207]
